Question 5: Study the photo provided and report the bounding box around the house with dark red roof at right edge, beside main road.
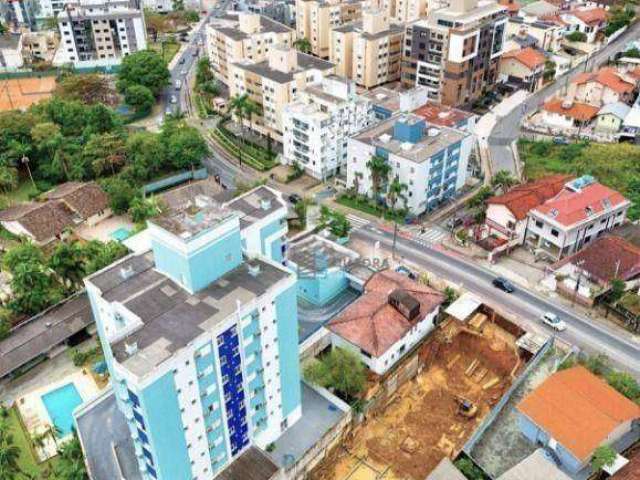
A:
[551,235,640,306]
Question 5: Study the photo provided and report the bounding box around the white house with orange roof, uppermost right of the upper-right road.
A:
[567,67,638,108]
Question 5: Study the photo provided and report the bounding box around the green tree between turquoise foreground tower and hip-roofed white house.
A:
[304,347,367,401]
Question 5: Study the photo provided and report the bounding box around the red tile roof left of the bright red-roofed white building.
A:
[487,175,571,220]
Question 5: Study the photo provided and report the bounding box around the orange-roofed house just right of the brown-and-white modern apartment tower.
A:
[499,47,545,92]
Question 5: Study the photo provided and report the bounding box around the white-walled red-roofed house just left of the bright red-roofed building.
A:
[485,175,571,240]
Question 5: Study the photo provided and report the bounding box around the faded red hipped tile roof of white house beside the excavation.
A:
[327,270,444,357]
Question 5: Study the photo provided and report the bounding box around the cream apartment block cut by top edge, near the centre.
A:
[296,0,370,60]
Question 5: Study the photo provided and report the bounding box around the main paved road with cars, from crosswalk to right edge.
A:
[352,224,640,378]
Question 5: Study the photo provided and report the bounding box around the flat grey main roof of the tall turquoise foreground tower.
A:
[89,252,293,376]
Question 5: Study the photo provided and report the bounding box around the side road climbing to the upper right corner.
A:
[488,23,640,174]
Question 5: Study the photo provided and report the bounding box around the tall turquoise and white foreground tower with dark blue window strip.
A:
[85,187,301,480]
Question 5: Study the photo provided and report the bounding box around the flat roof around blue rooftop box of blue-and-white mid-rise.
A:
[355,114,468,163]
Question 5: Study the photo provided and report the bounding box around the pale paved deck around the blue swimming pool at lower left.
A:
[16,368,100,460]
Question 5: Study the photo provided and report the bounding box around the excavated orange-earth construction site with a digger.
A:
[310,313,530,480]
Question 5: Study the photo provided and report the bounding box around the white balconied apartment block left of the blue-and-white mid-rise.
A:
[282,75,375,180]
